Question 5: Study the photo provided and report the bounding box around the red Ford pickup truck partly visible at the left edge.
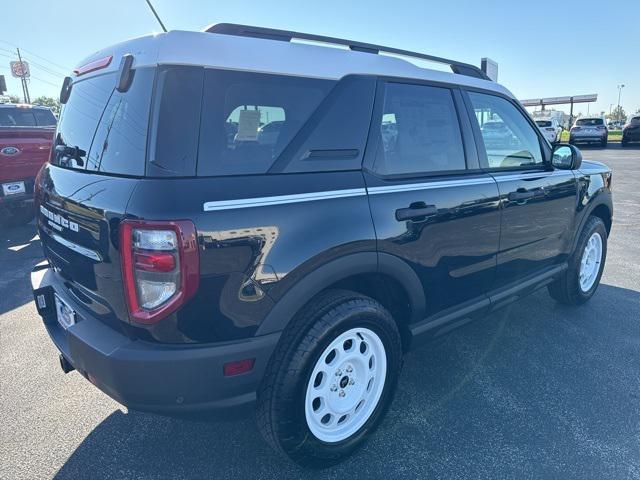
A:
[0,103,56,225]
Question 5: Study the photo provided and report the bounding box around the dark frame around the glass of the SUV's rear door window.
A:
[362,76,472,180]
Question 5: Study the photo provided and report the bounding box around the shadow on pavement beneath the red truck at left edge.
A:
[0,222,44,315]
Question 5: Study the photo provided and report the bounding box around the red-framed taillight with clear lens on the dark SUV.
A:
[120,220,200,324]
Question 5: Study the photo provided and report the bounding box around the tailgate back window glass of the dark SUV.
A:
[51,68,154,176]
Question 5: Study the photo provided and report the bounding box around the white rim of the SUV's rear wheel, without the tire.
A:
[304,328,387,443]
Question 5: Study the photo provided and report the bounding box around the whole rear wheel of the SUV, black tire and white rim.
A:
[256,290,402,467]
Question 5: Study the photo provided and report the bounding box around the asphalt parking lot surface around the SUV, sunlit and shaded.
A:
[0,144,640,480]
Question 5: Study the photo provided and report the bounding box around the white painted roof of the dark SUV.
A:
[78,30,514,98]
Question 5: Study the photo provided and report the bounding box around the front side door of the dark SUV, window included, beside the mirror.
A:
[465,91,577,287]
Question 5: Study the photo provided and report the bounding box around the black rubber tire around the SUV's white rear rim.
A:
[256,290,402,468]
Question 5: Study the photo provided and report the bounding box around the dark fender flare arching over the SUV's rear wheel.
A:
[255,252,426,336]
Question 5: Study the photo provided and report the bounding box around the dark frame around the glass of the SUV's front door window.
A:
[460,87,554,173]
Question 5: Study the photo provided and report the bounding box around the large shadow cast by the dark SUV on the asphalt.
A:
[56,285,640,479]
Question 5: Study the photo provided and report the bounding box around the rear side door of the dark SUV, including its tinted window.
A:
[364,80,500,317]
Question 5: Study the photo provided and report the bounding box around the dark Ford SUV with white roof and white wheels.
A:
[32,24,612,465]
